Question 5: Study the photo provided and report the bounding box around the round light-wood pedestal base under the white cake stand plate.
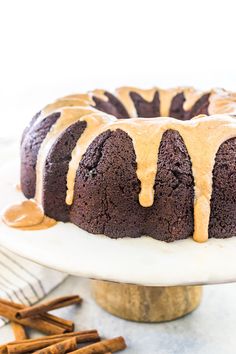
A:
[92,280,202,322]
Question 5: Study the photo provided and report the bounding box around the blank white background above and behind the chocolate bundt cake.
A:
[0,0,236,137]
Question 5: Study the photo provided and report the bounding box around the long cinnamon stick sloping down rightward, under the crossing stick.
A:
[0,299,74,334]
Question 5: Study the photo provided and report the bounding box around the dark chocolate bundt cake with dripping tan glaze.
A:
[18,87,236,242]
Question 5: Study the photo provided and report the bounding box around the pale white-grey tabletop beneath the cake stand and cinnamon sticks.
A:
[0,277,236,354]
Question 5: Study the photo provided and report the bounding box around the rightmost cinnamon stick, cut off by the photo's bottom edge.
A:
[68,337,126,354]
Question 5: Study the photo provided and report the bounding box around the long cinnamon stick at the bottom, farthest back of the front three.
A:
[7,330,100,354]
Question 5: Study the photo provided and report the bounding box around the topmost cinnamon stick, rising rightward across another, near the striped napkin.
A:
[16,295,82,319]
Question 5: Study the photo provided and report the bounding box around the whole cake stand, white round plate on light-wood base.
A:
[0,156,236,322]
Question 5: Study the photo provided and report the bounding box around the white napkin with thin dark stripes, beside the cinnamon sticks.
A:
[0,247,67,327]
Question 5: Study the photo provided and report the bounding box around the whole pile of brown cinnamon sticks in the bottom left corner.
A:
[0,295,126,354]
